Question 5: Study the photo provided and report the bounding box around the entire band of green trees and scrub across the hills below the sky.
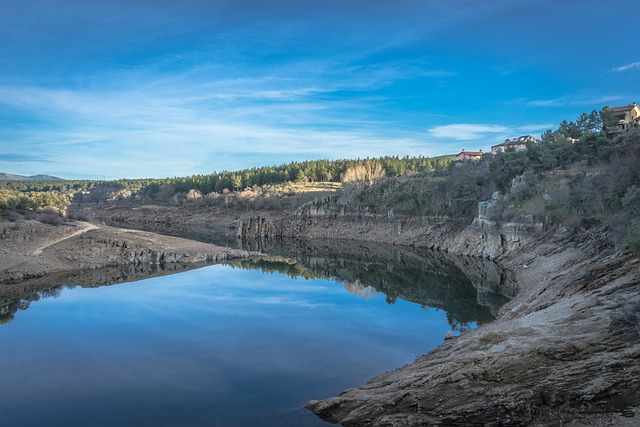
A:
[0,107,640,251]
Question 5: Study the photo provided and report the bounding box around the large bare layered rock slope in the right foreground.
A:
[307,230,640,426]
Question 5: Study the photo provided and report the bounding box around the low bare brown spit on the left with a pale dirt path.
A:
[0,221,257,283]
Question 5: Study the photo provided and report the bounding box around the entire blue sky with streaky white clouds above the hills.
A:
[0,0,640,179]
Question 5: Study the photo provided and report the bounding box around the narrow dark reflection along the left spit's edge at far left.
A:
[0,264,198,324]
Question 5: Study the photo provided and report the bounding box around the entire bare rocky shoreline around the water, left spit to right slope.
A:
[0,200,640,426]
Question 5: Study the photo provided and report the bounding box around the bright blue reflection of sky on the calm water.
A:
[0,265,450,426]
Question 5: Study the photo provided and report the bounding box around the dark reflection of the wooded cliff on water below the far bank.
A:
[231,241,516,331]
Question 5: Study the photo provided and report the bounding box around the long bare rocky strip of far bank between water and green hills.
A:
[91,195,542,259]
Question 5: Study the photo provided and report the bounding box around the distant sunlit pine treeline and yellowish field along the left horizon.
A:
[0,156,453,221]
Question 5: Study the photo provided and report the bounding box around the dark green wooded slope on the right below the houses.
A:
[354,108,640,250]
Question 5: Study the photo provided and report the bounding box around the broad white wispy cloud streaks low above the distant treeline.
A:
[0,58,439,177]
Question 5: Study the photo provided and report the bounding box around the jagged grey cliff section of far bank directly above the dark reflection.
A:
[236,196,542,259]
